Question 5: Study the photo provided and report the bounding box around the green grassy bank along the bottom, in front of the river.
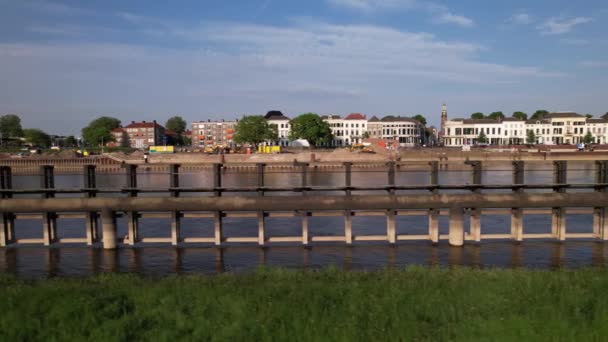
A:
[0,267,608,341]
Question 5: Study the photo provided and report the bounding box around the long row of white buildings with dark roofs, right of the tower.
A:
[441,112,608,146]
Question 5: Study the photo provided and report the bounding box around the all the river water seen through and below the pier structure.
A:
[0,162,608,278]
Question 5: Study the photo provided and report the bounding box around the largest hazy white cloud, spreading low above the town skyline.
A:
[0,20,562,132]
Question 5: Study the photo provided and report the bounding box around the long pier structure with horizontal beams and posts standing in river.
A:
[0,161,608,249]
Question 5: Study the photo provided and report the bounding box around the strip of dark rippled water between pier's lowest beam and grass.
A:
[0,241,606,278]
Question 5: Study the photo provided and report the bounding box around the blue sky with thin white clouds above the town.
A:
[0,0,608,135]
